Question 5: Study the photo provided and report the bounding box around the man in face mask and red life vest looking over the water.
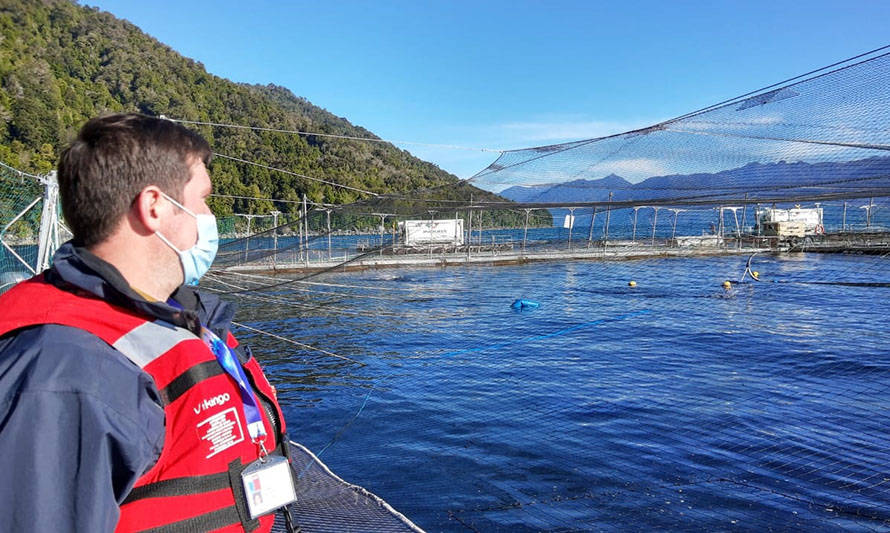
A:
[0,114,293,532]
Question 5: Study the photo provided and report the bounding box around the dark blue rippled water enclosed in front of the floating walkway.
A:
[239,254,890,531]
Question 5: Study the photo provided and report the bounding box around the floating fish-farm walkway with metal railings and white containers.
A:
[214,199,890,273]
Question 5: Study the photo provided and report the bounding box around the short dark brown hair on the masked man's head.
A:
[58,113,211,246]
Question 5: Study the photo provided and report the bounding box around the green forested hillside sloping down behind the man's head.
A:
[0,0,524,223]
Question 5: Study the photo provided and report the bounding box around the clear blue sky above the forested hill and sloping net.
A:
[85,0,890,178]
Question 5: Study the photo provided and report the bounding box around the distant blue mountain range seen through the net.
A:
[500,157,890,206]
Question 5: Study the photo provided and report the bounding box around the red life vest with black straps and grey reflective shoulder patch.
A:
[0,275,286,533]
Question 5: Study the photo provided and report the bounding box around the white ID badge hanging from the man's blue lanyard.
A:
[241,455,297,520]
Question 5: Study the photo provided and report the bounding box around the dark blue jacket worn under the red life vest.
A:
[0,243,234,532]
